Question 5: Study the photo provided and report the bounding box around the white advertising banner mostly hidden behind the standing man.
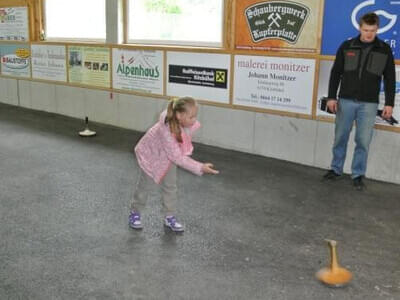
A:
[316,60,400,127]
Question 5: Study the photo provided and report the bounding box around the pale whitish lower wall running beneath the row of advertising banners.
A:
[0,77,400,183]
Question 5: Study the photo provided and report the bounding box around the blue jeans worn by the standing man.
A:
[331,98,378,179]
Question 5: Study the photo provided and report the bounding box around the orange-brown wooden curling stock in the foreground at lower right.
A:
[316,240,353,287]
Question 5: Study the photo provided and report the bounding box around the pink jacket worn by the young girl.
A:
[135,111,203,184]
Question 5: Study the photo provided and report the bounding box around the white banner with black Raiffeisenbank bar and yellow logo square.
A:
[167,52,230,103]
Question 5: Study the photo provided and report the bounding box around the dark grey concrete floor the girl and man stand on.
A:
[0,105,400,300]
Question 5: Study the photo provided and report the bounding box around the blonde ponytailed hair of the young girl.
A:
[165,96,196,143]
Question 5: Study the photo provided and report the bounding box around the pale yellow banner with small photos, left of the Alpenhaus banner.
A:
[68,46,110,88]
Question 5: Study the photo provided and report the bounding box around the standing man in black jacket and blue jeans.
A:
[324,13,396,190]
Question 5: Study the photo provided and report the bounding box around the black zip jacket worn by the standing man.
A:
[328,36,396,106]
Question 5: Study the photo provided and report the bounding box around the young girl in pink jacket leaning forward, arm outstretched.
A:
[129,97,218,232]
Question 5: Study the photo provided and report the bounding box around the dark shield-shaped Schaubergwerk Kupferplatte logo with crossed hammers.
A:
[245,1,310,44]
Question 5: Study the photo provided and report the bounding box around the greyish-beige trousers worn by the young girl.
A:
[131,164,178,216]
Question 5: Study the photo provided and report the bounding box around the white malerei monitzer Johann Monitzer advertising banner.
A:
[233,55,315,115]
